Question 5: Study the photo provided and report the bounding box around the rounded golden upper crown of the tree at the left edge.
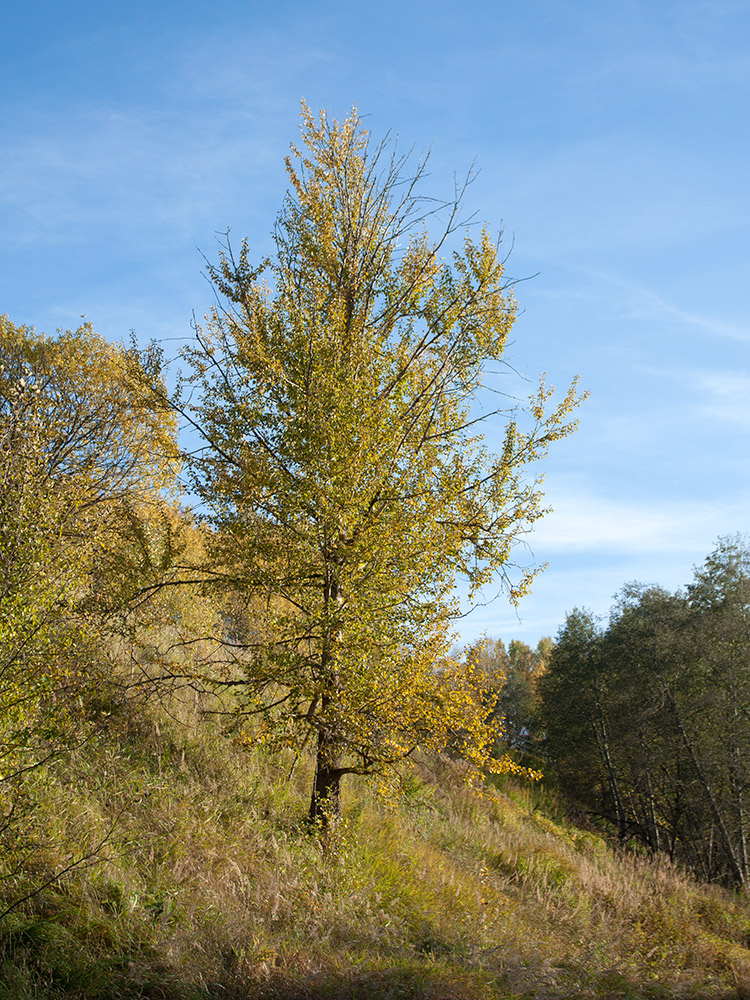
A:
[0,317,178,606]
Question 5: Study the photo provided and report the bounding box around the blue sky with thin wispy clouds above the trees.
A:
[0,0,750,642]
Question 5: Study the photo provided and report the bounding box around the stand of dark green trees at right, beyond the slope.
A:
[541,537,750,886]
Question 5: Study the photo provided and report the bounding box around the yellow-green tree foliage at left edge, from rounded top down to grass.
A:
[0,316,177,812]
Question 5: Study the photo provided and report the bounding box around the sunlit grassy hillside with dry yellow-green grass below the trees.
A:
[0,688,750,1000]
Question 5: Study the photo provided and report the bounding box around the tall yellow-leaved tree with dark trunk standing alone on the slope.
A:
[177,107,579,823]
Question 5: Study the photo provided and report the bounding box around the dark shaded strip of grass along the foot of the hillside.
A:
[0,936,750,1000]
